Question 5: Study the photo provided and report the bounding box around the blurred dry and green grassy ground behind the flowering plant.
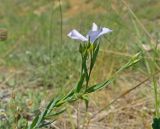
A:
[0,0,160,129]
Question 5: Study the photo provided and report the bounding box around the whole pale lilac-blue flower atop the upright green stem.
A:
[68,23,112,43]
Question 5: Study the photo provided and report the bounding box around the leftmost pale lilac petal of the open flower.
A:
[68,29,88,41]
